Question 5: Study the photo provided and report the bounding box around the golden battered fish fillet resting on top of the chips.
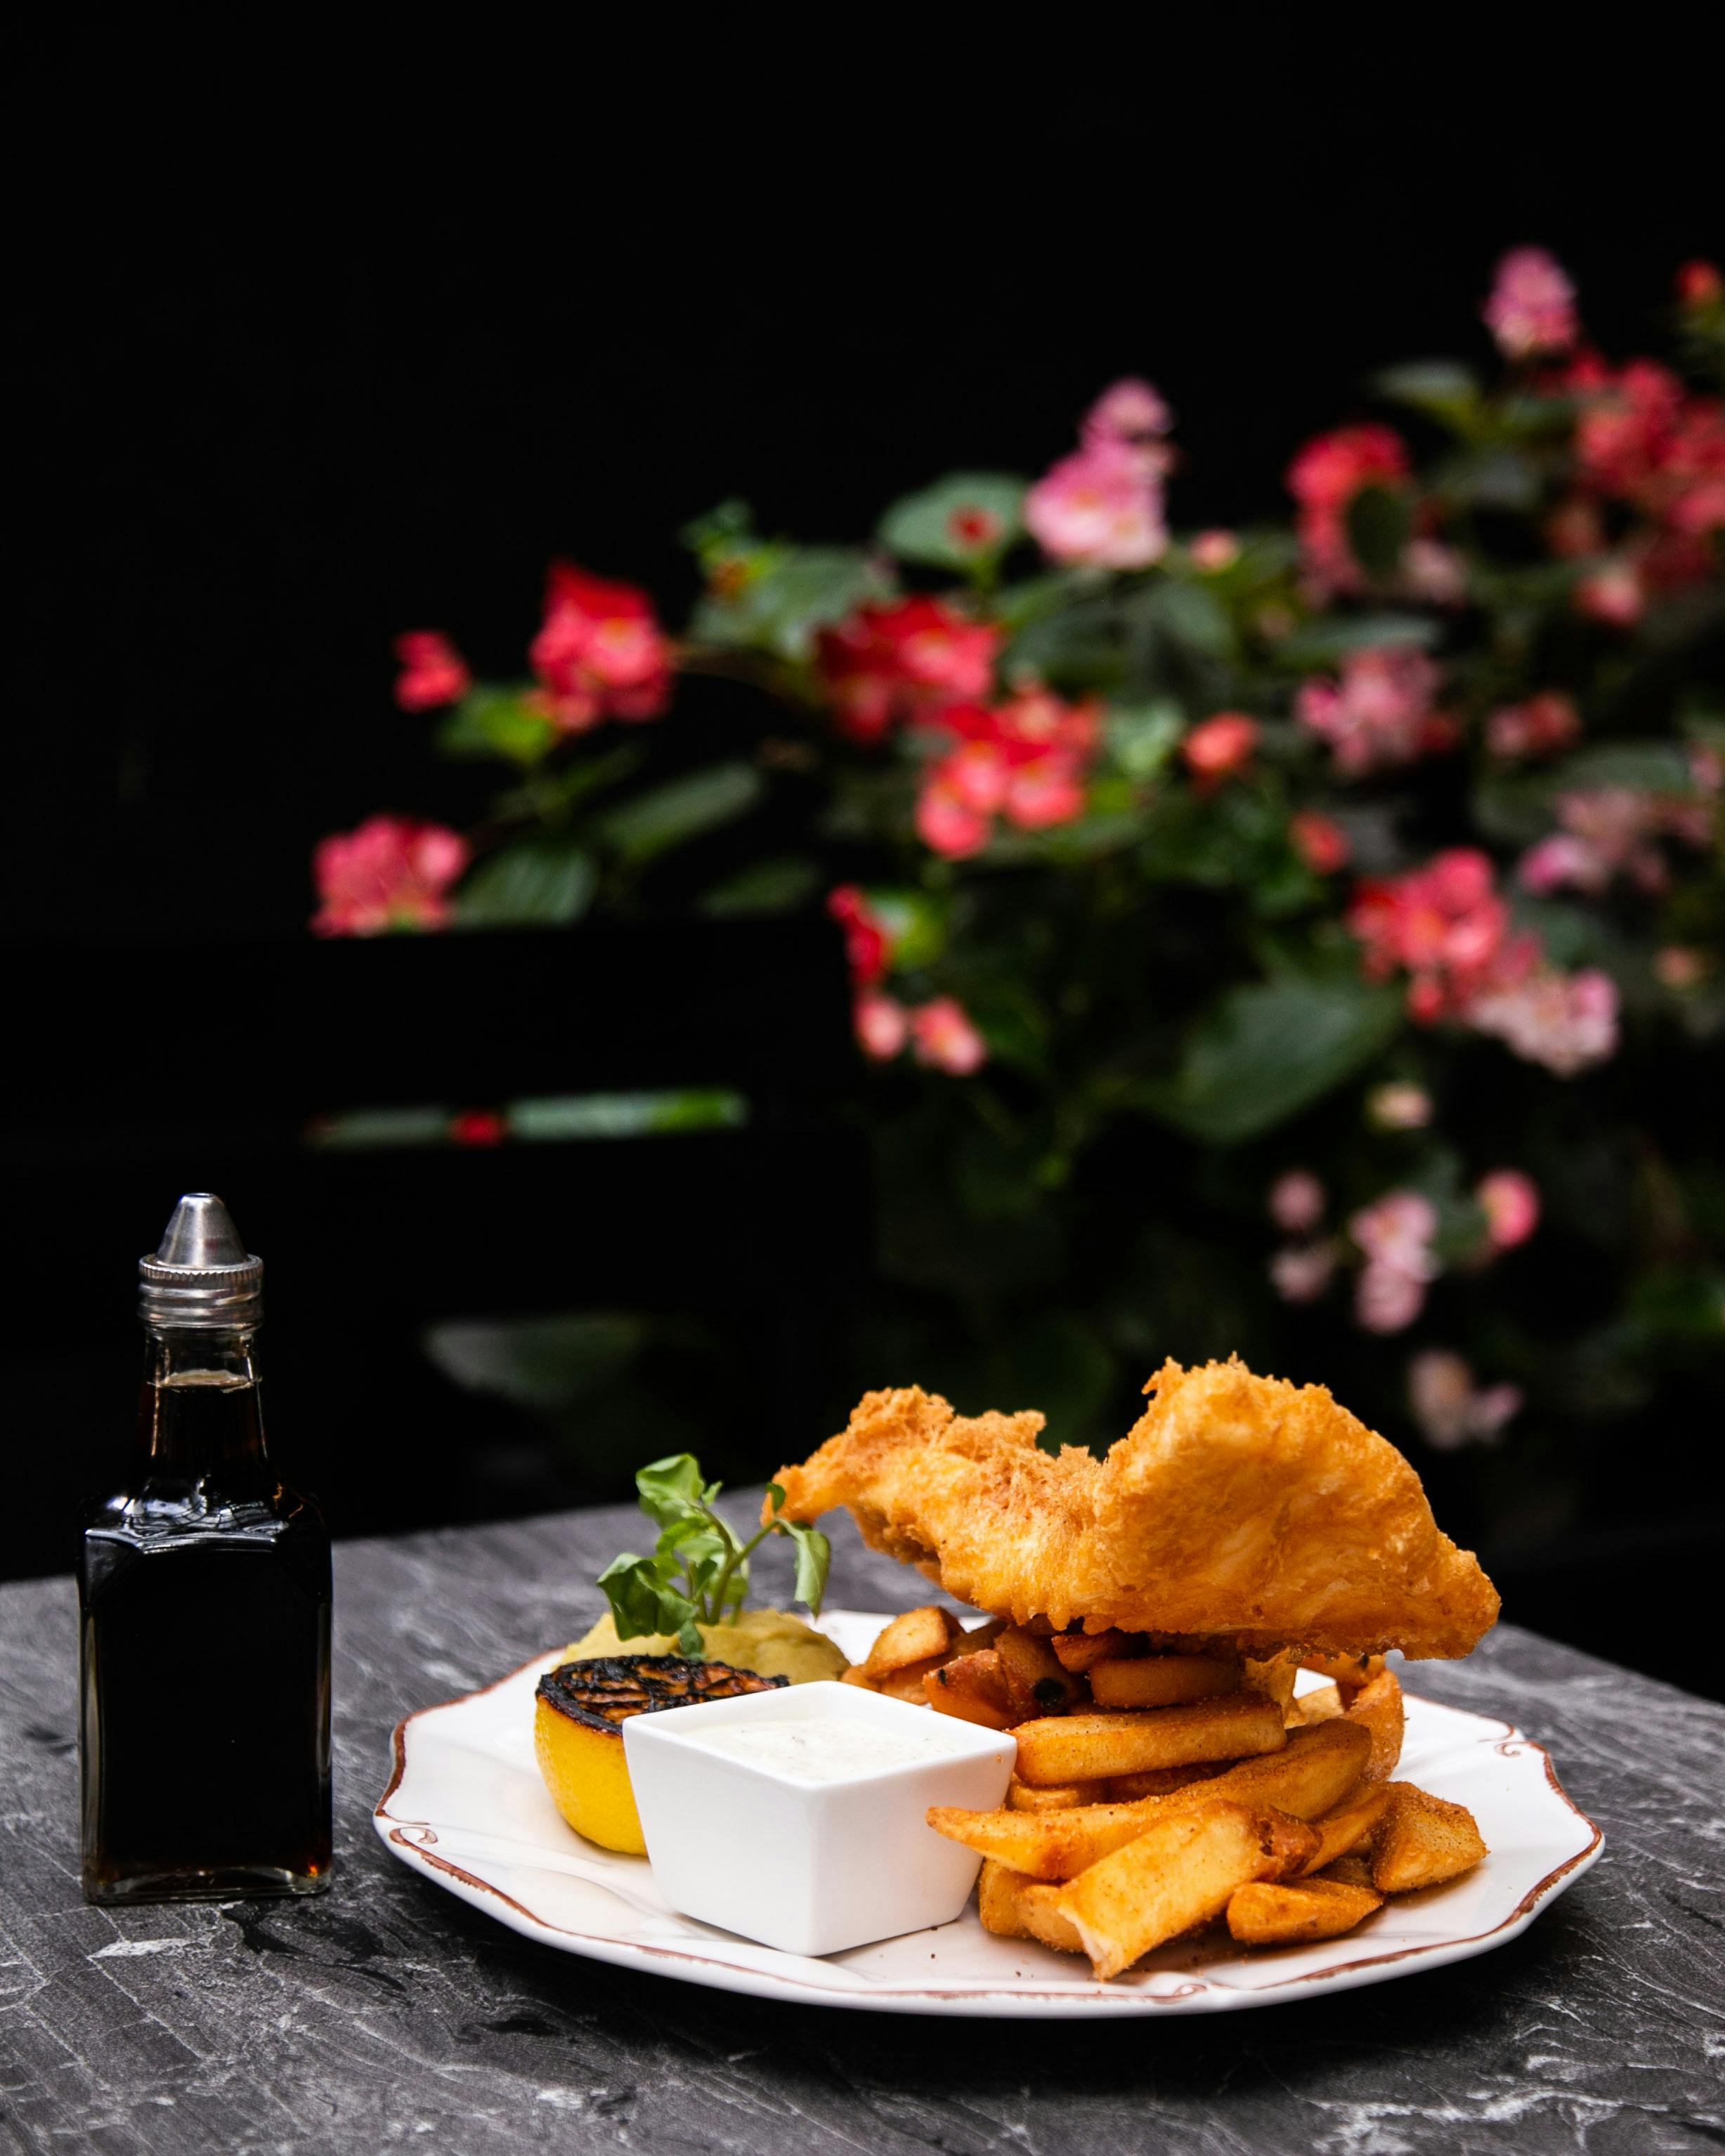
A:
[776,1358,1499,1658]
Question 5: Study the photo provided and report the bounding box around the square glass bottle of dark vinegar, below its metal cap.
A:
[80,1373,330,1902]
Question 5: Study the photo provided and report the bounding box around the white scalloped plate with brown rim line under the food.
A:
[375,1611,1600,2020]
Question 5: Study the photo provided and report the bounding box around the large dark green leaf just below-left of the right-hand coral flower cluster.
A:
[1145,974,1404,1145]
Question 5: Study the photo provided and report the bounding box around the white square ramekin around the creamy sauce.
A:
[623,1684,1017,1954]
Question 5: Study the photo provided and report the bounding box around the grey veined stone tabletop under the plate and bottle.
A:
[0,1507,1725,2156]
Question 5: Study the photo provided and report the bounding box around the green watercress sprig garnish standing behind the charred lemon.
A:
[599,1453,833,1656]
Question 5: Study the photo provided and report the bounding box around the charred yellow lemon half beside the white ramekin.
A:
[533,1654,785,1856]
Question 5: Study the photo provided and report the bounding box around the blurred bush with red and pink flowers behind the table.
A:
[315,248,1725,1516]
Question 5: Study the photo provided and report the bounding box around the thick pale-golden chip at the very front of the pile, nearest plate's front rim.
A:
[1055,1803,1268,1981]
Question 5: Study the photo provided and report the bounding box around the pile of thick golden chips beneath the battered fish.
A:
[845,1604,1485,1979]
